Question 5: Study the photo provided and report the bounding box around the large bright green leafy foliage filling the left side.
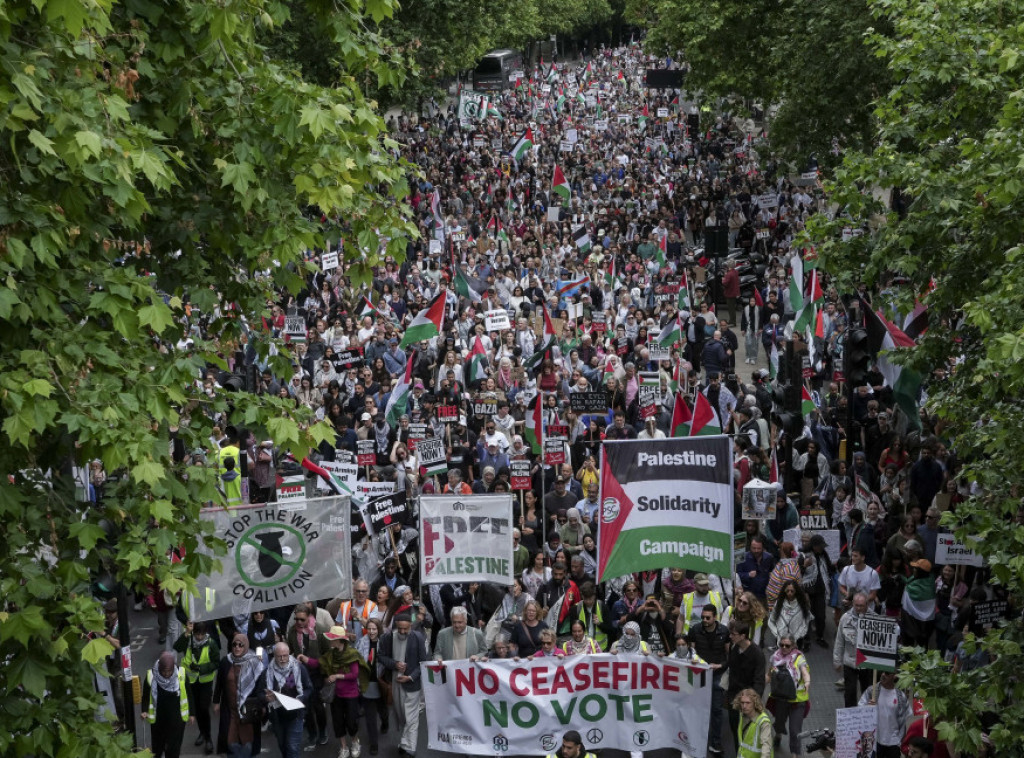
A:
[0,0,414,758]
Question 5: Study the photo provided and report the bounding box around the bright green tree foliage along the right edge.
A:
[814,0,1024,755]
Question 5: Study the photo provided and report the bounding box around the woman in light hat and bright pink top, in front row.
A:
[309,627,370,758]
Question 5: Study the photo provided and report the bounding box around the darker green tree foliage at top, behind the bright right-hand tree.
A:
[627,0,889,168]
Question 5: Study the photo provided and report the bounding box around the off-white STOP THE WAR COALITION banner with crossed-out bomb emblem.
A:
[190,497,352,621]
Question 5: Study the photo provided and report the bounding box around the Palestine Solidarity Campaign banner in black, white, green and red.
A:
[597,435,733,582]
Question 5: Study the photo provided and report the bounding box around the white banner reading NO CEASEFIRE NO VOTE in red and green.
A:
[422,654,712,758]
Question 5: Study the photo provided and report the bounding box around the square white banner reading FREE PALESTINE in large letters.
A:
[420,493,513,586]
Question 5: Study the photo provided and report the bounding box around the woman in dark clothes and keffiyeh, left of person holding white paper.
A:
[213,634,263,758]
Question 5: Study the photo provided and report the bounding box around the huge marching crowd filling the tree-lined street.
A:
[109,41,1004,758]
